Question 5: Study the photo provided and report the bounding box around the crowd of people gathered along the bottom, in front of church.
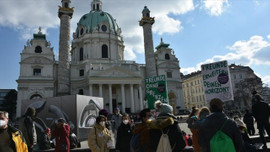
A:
[0,90,270,152]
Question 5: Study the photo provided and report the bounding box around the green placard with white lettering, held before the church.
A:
[145,75,168,109]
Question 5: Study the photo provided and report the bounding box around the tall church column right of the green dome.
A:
[140,6,157,78]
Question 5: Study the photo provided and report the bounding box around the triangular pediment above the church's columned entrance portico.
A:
[91,67,140,78]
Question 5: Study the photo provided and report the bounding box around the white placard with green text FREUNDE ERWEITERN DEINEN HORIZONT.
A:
[201,61,233,102]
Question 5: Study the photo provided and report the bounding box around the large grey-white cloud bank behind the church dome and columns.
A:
[0,0,195,60]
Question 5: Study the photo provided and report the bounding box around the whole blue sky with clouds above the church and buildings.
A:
[0,0,270,89]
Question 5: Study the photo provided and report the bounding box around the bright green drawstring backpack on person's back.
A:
[210,119,235,152]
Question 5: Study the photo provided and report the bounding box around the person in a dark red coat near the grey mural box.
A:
[52,118,70,152]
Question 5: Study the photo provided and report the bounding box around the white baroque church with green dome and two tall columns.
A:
[17,0,184,116]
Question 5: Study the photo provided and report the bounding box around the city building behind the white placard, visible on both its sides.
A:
[183,64,268,111]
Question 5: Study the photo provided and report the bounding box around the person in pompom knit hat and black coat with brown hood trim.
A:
[147,100,186,152]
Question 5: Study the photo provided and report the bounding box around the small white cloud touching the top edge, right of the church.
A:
[203,0,229,16]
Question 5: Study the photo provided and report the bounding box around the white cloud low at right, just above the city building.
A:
[181,35,270,75]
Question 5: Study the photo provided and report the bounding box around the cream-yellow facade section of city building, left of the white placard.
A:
[183,71,207,110]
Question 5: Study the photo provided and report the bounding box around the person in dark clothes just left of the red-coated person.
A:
[38,128,52,150]
